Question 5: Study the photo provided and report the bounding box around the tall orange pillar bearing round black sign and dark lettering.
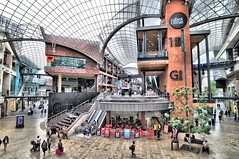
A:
[162,0,192,105]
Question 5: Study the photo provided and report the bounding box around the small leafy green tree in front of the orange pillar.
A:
[170,86,210,149]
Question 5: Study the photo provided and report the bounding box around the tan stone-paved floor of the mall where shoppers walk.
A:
[0,101,239,159]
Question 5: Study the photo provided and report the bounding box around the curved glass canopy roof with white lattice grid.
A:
[0,0,239,68]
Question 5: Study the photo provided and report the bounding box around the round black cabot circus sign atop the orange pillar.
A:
[169,12,187,29]
